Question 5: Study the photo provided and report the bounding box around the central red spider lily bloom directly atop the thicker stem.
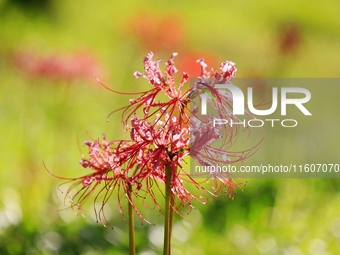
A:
[132,114,202,215]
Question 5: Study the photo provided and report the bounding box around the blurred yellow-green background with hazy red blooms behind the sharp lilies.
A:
[0,0,340,255]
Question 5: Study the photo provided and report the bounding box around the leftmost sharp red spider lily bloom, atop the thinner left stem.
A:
[48,136,150,225]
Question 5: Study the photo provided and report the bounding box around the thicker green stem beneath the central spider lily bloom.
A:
[163,165,173,255]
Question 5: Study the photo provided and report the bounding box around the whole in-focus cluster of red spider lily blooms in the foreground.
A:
[54,53,258,223]
